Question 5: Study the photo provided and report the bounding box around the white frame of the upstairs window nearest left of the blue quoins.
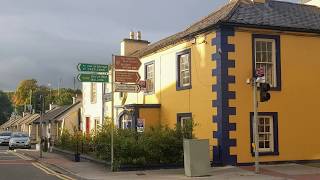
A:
[179,53,191,87]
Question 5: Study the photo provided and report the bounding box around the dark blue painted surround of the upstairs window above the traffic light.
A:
[252,34,281,91]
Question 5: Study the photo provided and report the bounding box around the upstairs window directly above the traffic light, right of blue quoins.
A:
[253,35,281,90]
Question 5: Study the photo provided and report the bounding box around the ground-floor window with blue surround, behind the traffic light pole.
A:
[251,112,279,155]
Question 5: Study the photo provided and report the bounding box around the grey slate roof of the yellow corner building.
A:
[131,0,320,57]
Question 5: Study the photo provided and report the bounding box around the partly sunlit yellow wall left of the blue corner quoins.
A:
[116,32,217,159]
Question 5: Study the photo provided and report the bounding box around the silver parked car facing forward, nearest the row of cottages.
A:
[9,132,31,150]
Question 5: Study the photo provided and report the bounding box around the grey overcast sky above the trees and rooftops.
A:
[0,0,298,91]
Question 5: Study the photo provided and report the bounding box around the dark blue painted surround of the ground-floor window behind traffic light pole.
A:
[250,112,279,156]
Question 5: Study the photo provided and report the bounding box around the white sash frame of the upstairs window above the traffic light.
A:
[254,38,277,87]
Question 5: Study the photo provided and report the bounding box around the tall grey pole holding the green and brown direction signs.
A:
[110,55,115,171]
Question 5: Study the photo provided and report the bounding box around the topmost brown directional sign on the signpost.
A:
[115,56,141,70]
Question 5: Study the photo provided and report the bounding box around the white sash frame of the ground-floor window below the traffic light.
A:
[253,115,274,152]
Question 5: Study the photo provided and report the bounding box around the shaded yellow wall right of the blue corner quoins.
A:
[234,31,320,163]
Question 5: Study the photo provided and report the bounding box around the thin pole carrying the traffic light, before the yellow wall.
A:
[253,77,259,173]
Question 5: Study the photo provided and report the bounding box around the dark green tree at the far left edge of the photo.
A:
[0,91,13,124]
